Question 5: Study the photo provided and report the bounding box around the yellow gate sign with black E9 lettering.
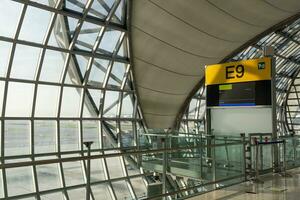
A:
[205,57,271,85]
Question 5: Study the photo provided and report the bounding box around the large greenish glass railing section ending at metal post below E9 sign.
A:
[140,133,245,192]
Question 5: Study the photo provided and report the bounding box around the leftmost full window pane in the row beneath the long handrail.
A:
[6,167,34,196]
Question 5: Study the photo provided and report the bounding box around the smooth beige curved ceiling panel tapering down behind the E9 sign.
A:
[131,0,300,128]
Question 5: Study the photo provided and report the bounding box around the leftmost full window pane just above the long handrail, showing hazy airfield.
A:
[4,120,30,156]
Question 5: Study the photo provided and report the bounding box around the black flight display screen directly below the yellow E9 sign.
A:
[206,80,271,106]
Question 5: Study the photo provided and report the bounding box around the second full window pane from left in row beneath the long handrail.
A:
[36,164,61,191]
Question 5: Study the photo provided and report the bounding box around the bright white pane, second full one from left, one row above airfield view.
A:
[35,85,60,117]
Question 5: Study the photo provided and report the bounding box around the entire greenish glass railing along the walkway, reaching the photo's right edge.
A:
[134,132,300,198]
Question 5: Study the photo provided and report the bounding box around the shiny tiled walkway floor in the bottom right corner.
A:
[189,168,300,200]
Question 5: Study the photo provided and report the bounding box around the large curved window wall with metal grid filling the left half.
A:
[0,0,146,200]
